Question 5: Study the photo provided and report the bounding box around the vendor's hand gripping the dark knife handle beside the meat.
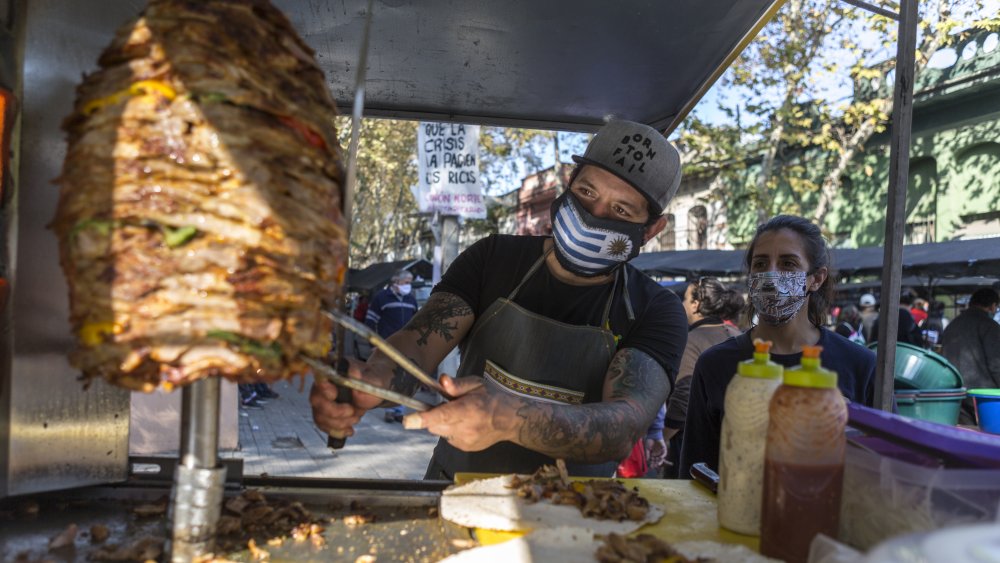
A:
[309,359,382,437]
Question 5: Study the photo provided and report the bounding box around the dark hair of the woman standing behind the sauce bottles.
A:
[744,215,833,327]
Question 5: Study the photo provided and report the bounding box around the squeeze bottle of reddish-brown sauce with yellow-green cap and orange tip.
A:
[760,346,847,563]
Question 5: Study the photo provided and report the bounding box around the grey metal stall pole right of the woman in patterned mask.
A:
[875,0,920,411]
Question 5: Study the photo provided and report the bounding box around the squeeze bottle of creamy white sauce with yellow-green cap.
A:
[719,339,783,536]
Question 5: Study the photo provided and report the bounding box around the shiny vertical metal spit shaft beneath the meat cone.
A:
[168,377,226,562]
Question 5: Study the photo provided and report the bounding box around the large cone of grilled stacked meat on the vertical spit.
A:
[52,0,347,391]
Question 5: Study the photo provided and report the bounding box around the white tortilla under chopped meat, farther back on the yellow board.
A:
[441,475,663,534]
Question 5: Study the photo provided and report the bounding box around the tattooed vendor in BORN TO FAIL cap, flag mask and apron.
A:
[310,120,687,479]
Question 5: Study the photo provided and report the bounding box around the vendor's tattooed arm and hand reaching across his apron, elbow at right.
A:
[413,348,670,463]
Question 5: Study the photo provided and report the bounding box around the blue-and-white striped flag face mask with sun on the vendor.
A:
[552,192,646,277]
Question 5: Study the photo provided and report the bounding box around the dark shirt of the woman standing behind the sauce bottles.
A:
[678,328,875,479]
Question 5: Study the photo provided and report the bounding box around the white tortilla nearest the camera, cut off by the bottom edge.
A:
[441,527,780,563]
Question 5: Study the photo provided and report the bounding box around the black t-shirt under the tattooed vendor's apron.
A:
[432,235,687,387]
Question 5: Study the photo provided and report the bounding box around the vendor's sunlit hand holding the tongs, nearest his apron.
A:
[403,375,516,452]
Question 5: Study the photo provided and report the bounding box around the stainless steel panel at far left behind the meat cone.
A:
[0,0,141,496]
